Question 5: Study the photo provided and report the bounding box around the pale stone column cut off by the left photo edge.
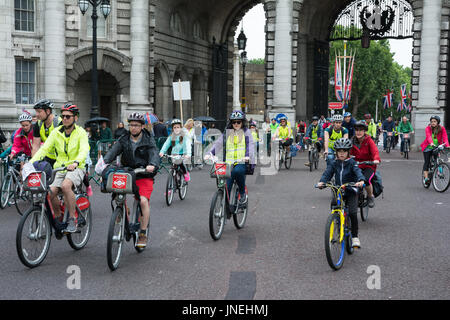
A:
[0,0,16,117]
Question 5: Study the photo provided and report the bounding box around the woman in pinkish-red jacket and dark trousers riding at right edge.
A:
[420,115,450,183]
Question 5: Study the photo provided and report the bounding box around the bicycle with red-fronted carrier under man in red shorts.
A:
[106,168,150,271]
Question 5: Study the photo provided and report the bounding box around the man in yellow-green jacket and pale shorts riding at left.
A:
[30,103,89,233]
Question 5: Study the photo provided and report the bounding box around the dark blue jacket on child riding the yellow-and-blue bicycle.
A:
[320,158,366,186]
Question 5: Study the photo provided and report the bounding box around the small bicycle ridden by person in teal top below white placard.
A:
[164,155,188,206]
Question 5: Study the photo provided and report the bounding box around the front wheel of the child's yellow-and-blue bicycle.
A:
[325,212,345,270]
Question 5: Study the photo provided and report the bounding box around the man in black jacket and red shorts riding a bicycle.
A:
[104,112,160,248]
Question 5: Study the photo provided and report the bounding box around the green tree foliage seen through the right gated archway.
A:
[329,40,411,119]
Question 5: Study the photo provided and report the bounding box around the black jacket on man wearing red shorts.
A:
[104,129,160,178]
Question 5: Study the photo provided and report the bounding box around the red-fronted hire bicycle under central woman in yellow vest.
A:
[209,159,248,240]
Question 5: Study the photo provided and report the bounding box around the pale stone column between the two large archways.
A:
[269,0,295,124]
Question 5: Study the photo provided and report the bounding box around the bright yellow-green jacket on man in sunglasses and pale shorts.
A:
[30,125,89,169]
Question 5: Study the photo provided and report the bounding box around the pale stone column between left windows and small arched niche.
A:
[44,0,66,106]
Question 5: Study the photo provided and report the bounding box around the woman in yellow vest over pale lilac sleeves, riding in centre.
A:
[205,110,255,206]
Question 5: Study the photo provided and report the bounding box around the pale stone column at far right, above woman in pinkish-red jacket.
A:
[412,0,444,146]
